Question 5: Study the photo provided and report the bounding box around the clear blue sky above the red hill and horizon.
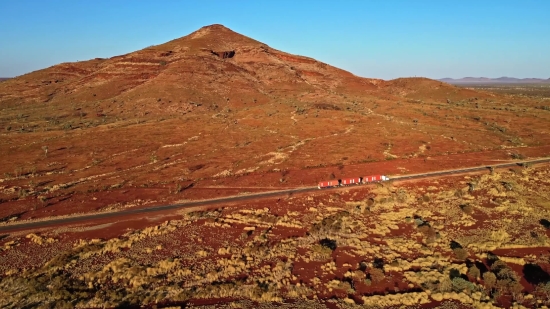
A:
[0,0,550,79]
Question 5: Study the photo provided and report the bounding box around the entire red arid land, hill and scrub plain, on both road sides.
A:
[0,21,550,309]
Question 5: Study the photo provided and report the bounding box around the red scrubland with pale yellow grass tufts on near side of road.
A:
[0,166,550,308]
